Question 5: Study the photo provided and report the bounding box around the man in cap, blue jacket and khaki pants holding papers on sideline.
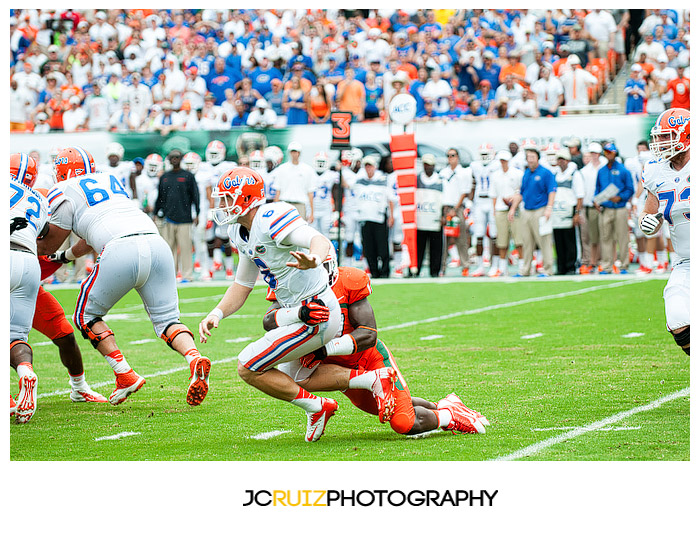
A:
[594,142,634,274]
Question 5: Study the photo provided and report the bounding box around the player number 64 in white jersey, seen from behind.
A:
[37,147,211,406]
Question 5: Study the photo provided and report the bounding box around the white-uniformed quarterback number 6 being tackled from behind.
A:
[199,167,342,441]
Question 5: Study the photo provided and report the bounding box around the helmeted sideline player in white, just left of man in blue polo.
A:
[470,143,500,277]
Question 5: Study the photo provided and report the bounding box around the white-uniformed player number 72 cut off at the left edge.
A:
[10,154,50,423]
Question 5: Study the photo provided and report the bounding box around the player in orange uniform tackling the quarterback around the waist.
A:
[263,255,489,435]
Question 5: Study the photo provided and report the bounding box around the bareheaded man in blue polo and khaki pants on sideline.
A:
[508,145,557,277]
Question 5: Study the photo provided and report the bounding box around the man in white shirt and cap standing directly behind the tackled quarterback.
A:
[270,141,316,223]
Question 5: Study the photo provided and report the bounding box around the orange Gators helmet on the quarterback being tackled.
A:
[211,167,265,225]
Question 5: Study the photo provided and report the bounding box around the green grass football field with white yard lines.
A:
[10,276,690,461]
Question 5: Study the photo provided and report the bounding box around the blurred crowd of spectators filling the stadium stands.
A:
[10,9,690,134]
